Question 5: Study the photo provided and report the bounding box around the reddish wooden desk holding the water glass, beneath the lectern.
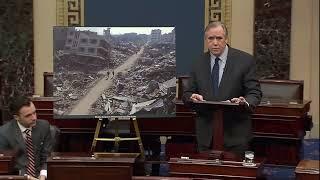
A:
[169,158,262,179]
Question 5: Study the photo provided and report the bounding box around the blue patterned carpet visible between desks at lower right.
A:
[263,139,320,180]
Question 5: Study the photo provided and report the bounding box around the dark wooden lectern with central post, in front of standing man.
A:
[194,101,245,160]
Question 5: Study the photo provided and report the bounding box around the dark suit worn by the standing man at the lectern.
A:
[183,47,262,150]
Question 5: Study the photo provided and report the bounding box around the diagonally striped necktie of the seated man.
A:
[24,129,36,177]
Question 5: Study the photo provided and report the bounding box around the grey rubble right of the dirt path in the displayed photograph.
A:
[91,43,176,116]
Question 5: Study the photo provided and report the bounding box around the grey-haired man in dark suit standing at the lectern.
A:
[183,22,262,157]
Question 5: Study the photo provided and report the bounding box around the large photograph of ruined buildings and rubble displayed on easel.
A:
[53,27,176,118]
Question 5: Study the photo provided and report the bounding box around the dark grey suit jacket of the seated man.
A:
[0,119,51,176]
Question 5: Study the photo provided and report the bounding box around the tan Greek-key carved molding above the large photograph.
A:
[56,0,84,26]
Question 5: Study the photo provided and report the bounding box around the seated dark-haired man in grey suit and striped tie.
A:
[0,97,52,179]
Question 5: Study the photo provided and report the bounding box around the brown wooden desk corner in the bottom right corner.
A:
[295,160,320,180]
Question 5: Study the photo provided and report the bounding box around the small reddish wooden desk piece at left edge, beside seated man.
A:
[0,152,15,175]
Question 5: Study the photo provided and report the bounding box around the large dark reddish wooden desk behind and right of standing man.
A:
[252,99,311,166]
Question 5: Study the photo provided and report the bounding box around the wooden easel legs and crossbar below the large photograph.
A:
[91,116,145,159]
